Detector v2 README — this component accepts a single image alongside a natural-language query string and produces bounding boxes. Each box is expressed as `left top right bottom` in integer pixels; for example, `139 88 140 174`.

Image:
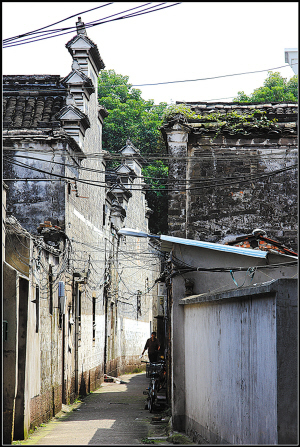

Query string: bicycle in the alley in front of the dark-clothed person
142 360 166 413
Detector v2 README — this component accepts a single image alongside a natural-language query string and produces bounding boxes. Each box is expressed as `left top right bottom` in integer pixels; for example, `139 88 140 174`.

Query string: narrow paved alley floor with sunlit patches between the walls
14 373 195 445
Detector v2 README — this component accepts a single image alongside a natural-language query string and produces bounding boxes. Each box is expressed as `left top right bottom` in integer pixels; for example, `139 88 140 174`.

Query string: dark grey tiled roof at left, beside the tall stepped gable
3 75 67 129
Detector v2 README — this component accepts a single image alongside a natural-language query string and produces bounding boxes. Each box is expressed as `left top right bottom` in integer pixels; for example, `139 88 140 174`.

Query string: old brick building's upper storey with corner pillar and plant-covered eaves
162 103 298 251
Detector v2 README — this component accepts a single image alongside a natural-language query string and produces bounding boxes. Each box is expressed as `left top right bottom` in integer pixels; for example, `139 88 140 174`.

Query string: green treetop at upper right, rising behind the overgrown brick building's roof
234 71 298 103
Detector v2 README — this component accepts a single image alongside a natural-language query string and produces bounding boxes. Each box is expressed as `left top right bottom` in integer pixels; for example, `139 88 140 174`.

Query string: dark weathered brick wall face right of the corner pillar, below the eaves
187 137 297 249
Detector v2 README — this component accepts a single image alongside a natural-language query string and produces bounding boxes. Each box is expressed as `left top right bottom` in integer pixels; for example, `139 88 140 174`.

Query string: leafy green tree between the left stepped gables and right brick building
98 70 168 234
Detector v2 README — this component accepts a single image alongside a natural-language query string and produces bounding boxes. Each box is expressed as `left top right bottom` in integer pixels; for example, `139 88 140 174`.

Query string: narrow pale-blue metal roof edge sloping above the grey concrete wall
160 235 268 258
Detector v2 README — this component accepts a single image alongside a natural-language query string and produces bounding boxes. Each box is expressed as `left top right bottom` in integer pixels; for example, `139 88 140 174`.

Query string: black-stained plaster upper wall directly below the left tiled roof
3 142 65 234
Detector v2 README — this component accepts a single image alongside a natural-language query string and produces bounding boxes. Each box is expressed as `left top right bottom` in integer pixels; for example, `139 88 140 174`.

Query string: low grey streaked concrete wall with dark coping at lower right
178 279 298 445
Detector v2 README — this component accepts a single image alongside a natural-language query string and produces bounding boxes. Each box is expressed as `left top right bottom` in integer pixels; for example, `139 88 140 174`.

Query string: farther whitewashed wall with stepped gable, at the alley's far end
108 154 160 371
